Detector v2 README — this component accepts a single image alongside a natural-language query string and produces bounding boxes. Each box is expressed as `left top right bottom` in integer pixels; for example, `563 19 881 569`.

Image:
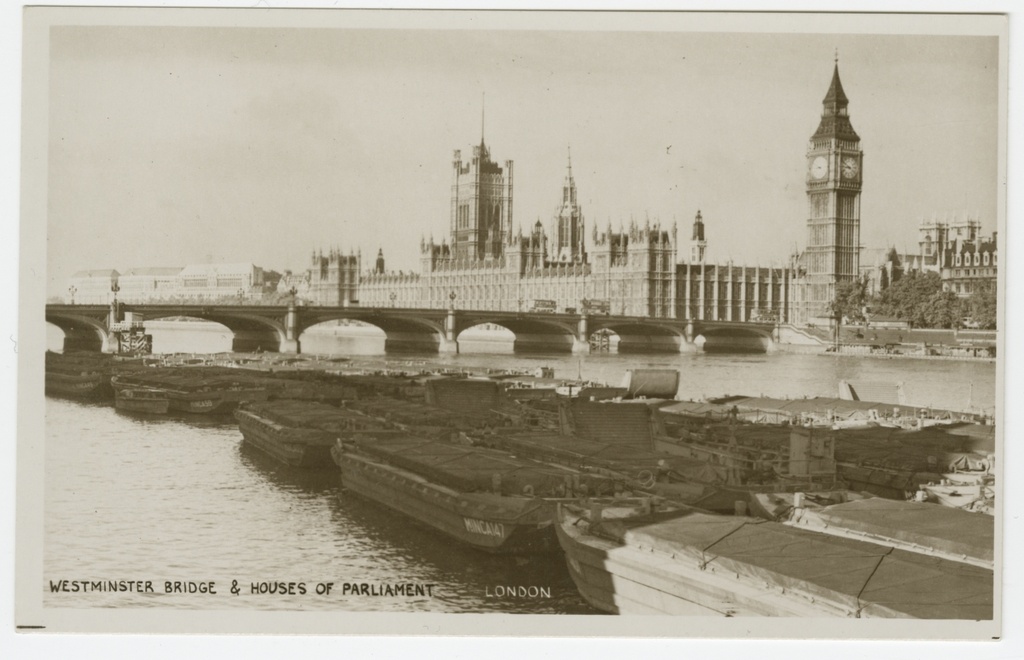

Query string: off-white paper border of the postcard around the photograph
6 2 1016 654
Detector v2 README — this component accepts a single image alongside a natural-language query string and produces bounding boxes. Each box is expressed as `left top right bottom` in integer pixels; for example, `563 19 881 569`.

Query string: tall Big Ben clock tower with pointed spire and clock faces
804 57 864 320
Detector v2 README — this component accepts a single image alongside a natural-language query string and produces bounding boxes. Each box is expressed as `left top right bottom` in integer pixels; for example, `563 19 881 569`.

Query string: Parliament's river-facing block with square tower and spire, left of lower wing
327 139 677 318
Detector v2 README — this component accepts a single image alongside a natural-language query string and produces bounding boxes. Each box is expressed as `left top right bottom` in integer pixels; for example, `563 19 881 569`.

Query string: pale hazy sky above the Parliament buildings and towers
48 27 998 295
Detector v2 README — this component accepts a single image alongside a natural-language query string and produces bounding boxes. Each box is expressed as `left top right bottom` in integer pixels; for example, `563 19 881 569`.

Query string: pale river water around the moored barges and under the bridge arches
42 327 995 614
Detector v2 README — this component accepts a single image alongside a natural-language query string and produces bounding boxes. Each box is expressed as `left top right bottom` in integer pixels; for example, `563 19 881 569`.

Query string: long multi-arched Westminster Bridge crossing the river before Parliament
46 303 777 354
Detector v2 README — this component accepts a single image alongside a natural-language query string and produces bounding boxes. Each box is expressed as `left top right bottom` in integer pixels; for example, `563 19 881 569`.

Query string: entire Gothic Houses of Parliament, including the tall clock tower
307 61 880 323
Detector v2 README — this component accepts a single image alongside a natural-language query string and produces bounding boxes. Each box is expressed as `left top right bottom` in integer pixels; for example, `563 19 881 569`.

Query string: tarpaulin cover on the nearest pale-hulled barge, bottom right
592 513 993 620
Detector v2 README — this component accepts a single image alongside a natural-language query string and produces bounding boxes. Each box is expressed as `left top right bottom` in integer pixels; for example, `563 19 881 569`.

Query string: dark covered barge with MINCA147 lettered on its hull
331 432 614 555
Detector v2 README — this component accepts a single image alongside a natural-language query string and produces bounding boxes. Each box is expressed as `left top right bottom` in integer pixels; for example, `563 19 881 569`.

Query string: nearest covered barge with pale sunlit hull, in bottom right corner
556 499 994 620
